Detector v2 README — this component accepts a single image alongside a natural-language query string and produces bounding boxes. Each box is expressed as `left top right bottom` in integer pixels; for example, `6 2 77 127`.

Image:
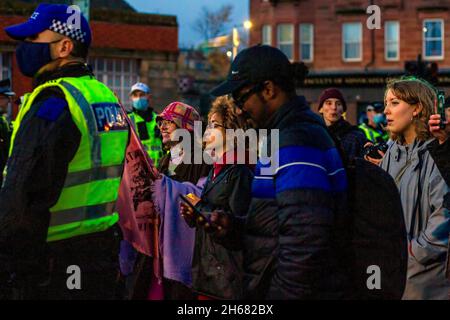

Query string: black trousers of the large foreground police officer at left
42 226 122 300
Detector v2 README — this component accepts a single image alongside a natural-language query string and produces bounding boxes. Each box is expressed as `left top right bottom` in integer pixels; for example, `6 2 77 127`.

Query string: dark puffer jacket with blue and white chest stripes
244 97 347 299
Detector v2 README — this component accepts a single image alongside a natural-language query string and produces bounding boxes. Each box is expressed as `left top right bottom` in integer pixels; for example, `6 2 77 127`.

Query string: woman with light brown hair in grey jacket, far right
381 78 450 300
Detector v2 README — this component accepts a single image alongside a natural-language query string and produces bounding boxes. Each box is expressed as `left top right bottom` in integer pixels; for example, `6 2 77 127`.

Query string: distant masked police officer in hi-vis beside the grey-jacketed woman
359 102 389 143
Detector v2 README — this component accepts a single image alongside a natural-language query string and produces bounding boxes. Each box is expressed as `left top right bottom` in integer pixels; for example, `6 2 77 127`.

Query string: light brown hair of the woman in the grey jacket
384 78 437 141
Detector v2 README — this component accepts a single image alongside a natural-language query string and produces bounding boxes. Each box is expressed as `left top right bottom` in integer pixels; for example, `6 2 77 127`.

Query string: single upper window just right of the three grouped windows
342 22 362 62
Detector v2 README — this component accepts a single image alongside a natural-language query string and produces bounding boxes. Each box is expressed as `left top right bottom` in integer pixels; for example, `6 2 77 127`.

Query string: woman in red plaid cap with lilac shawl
127 102 211 300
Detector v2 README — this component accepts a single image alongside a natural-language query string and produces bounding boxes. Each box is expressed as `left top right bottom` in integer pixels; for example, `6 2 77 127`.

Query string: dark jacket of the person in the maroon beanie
328 118 368 159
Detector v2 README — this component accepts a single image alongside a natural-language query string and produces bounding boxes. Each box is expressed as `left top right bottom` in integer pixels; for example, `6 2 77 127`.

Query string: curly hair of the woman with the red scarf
208 96 254 130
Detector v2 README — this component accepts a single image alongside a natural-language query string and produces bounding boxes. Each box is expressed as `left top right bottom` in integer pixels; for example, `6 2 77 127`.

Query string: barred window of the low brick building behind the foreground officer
89 58 139 108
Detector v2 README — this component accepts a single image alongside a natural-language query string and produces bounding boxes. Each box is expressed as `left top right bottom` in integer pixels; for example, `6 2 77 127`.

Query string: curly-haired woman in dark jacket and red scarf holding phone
181 97 253 300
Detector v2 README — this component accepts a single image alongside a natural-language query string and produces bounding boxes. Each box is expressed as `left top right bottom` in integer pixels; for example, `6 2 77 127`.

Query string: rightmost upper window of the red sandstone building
423 19 444 59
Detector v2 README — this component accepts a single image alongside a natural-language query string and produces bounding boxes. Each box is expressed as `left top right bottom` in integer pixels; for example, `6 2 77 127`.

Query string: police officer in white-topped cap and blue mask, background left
129 82 162 166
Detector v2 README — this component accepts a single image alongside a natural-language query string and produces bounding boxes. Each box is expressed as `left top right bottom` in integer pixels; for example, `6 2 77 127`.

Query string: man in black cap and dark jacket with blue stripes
205 45 347 299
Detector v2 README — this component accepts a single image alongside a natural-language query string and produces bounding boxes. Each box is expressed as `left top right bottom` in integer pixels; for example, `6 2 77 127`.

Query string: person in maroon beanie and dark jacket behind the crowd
319 88 367 160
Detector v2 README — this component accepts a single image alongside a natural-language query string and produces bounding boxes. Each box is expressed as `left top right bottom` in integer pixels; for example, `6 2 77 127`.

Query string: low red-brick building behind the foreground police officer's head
0 0 178 112
